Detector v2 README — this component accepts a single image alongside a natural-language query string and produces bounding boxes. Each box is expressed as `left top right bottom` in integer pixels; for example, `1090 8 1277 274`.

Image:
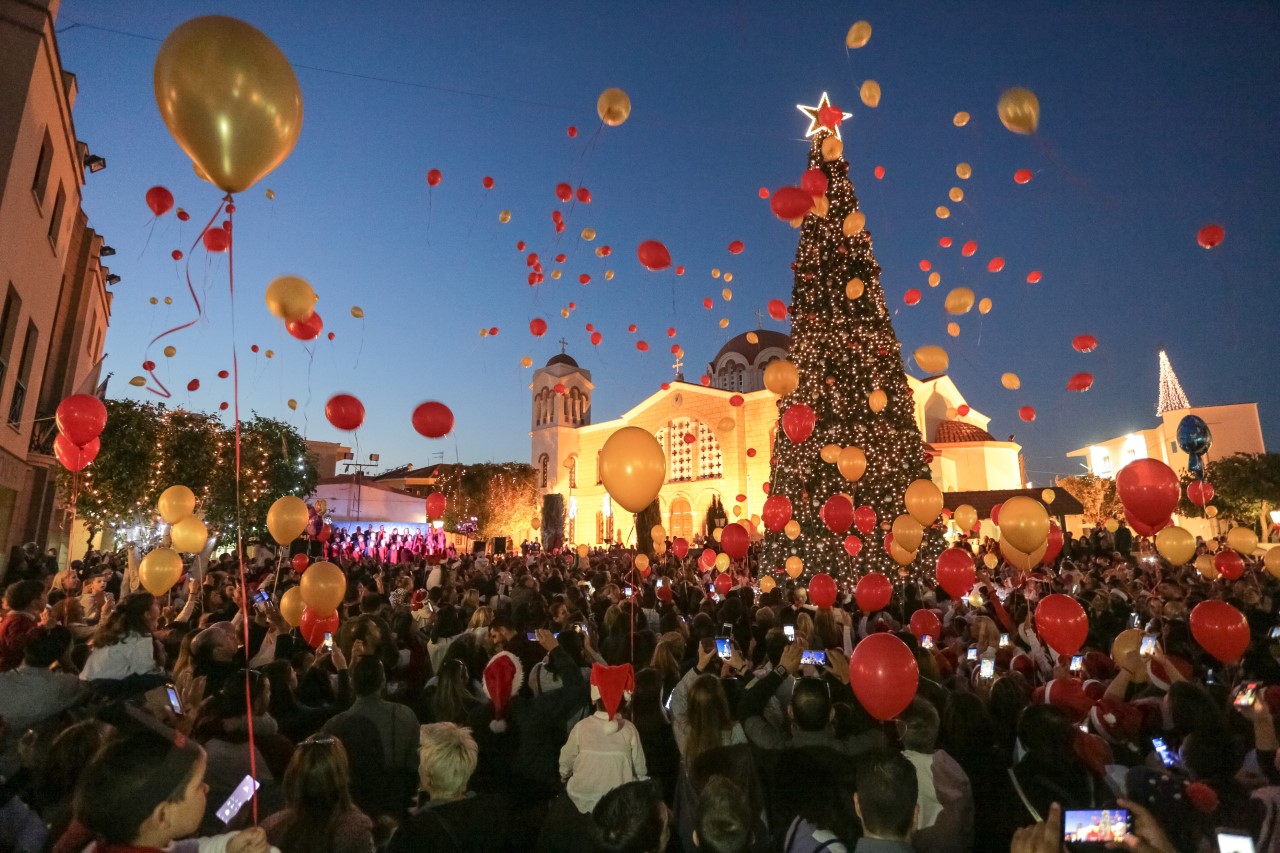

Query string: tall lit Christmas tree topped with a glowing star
762 93 943 585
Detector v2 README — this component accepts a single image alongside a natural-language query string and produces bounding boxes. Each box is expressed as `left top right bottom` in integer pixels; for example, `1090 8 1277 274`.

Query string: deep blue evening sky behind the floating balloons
58 0 1280 483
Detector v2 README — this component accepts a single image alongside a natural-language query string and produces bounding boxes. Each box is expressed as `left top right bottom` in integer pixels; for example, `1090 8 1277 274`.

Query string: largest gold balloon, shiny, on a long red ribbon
154 15 302 192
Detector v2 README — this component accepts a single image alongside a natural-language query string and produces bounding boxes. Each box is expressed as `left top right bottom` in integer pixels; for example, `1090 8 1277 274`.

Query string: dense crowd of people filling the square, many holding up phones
0 517 1280 853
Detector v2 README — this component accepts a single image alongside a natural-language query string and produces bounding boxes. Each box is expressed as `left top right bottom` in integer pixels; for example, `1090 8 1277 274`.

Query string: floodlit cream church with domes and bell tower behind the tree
530 329 1025 544
